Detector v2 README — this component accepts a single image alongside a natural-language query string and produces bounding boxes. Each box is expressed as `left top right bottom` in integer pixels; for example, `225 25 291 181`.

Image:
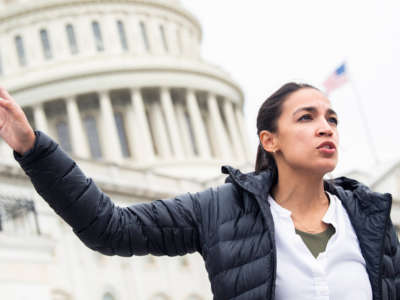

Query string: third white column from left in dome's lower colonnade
99 91 122 162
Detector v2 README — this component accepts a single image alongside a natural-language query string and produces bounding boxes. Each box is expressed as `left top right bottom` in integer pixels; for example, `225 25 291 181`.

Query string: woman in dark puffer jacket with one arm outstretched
0 83 400 300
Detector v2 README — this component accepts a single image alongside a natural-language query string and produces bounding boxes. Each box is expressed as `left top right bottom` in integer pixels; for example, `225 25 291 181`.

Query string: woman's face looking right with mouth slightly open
275 88 339 175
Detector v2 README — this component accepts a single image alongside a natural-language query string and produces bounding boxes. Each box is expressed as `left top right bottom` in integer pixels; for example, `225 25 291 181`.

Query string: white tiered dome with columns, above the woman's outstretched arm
0 0 252 179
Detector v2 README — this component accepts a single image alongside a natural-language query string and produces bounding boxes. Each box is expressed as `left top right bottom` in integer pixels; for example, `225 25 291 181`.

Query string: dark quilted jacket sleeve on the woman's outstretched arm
14 132 207 256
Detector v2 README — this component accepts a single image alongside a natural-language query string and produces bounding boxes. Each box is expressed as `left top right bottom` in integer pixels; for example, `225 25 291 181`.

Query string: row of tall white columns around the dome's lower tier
11 85 252 164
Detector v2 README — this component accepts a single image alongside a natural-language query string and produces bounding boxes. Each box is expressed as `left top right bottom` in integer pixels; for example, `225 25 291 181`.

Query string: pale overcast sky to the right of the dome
181 0 400 173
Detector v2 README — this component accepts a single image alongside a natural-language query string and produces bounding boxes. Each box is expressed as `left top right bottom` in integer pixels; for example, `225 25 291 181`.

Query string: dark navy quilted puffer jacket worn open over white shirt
15 132 400 300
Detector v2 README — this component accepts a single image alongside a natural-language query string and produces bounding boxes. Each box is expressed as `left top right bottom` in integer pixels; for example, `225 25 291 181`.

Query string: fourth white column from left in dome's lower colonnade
131 89 154 161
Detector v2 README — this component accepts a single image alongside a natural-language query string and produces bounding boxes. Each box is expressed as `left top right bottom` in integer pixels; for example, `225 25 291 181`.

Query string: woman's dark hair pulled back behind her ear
255 82 318 179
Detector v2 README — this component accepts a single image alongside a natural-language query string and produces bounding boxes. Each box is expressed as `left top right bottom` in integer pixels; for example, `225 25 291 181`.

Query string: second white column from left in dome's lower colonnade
65 96 90 158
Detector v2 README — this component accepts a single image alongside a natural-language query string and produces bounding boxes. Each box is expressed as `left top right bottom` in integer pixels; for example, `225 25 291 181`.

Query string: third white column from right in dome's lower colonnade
207 93 232 159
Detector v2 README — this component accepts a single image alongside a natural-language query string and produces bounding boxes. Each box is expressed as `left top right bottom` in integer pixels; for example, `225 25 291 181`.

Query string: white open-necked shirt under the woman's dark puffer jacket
268 194 372 300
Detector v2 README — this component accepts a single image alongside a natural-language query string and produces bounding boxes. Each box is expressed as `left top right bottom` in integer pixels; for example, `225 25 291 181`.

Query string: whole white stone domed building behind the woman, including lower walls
0 0 254 300
